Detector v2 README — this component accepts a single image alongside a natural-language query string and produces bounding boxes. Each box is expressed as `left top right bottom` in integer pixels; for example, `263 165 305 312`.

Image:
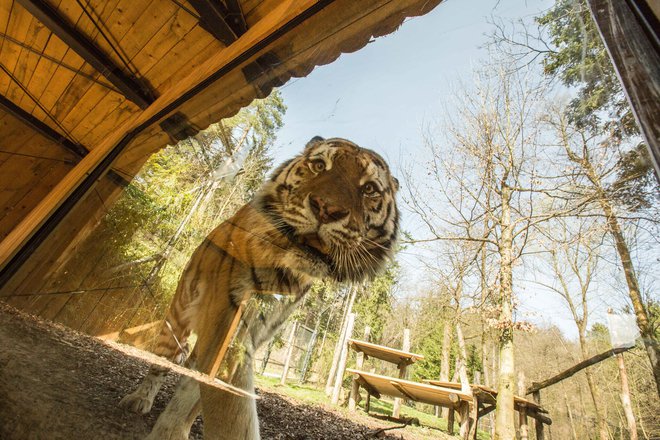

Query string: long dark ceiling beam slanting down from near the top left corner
17 0 155 109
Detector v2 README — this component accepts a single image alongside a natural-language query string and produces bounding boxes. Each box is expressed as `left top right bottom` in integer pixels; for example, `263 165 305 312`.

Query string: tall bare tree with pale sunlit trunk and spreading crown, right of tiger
406 69 560 439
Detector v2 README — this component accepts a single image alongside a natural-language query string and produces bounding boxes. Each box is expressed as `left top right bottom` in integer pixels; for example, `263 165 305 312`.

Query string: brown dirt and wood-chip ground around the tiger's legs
0 302 408 440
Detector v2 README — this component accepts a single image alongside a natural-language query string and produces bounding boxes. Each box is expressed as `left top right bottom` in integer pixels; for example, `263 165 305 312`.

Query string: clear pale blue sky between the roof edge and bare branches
266 0 628 336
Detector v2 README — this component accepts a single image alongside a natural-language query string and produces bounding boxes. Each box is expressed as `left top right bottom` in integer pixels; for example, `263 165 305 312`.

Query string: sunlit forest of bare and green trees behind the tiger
42 0 660 440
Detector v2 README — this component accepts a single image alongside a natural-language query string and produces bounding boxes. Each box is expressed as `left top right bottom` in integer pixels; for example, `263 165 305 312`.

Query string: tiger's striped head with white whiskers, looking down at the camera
261 137 399 281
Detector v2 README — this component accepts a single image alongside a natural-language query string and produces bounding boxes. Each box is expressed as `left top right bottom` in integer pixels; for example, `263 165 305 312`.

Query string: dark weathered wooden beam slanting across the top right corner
587 0 660 180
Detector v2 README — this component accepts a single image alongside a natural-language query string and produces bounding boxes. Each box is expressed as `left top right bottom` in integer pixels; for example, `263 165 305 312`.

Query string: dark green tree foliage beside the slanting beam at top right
536 0 638 138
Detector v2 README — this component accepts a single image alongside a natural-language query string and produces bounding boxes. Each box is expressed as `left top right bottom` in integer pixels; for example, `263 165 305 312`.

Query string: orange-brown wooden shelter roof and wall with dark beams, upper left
0 0 441 335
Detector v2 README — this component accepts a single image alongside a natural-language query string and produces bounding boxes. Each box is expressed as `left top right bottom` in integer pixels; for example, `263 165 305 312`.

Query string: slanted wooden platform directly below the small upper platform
346 368 473 407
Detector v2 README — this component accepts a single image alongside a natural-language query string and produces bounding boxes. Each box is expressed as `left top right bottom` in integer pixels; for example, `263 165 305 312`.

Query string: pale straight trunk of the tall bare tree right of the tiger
495 183 516 440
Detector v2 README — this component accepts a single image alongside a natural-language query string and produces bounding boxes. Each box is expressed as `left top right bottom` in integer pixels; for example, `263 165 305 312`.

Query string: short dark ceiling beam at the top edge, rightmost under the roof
188 0 247 46
